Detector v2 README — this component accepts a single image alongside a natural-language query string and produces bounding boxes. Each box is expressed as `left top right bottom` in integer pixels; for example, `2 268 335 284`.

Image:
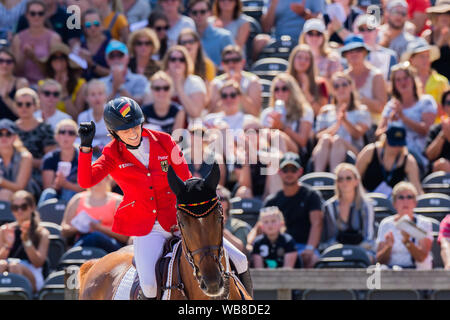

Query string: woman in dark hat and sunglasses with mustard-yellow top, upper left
43 43 86 119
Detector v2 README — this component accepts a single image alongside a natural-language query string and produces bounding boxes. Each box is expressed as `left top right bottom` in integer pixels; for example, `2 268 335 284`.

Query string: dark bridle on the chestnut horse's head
177 199 225 284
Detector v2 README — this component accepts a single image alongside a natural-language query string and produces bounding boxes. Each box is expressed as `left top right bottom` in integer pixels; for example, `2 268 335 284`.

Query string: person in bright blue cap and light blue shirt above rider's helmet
100 40 150 103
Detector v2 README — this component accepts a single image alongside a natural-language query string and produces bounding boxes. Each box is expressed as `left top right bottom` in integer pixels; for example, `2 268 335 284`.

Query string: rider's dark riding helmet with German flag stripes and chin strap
103 97 144 149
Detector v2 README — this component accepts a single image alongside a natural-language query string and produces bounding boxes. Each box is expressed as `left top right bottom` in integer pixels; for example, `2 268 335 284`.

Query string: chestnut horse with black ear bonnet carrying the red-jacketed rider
79 164 251 300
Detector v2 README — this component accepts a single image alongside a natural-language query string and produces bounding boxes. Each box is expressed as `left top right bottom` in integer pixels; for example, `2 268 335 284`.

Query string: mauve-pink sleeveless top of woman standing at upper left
18 29 54 84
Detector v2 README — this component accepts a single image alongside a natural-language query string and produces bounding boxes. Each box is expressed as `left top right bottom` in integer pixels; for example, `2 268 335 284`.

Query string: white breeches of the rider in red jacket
133 221 248 298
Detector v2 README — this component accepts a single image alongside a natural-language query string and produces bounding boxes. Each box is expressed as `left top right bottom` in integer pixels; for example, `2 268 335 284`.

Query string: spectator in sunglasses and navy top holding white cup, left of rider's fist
38 119 84 206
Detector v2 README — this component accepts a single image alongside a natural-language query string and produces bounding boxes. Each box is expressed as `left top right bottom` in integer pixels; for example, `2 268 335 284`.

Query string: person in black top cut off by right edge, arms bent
425 90 450 172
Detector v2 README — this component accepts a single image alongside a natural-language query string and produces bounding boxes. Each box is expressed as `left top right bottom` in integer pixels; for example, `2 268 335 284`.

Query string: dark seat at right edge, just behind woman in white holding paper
414 193 450 221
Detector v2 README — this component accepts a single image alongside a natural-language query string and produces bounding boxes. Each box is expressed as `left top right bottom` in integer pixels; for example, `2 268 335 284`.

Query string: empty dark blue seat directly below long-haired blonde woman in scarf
314 244 371 269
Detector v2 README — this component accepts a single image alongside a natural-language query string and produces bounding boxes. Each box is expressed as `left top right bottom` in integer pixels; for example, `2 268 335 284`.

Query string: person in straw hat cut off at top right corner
422 0 450 79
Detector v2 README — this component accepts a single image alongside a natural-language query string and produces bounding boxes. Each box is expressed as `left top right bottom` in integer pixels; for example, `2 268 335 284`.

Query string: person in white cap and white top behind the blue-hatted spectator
353 14 397 81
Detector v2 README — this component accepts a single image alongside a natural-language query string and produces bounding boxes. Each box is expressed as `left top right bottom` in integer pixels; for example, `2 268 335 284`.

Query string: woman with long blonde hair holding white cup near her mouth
261 73 314 156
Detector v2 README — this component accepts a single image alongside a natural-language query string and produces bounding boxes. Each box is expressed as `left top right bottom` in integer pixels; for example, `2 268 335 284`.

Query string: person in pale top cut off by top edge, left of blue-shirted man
158 0 195 47
